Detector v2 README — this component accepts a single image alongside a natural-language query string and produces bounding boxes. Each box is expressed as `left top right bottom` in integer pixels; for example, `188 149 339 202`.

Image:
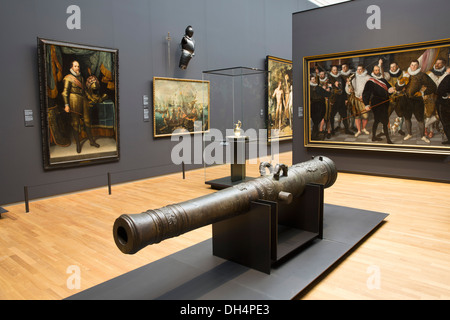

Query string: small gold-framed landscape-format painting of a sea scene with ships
153 77 210 137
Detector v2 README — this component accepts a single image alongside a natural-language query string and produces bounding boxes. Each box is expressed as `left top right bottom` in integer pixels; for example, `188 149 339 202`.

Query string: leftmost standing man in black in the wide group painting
309 76 331 140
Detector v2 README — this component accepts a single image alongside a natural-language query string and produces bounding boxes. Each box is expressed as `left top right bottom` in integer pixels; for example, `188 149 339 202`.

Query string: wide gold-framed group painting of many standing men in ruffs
303 39 450 154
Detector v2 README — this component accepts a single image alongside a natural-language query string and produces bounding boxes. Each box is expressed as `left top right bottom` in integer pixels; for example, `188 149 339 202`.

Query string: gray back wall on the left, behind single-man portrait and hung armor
0 0 315 205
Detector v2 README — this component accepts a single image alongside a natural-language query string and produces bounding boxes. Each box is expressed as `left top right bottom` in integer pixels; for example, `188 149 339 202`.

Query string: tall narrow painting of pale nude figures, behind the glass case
266 56 293 142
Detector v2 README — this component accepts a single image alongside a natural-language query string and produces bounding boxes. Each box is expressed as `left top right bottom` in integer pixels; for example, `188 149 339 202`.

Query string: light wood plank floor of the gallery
0 153 450 300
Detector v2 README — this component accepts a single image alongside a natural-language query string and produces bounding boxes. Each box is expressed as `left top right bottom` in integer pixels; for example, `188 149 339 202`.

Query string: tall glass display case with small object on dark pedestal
202 67 278 189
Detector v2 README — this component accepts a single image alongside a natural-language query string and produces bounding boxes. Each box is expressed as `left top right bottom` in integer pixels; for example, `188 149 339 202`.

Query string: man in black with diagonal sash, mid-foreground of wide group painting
362 66 395 144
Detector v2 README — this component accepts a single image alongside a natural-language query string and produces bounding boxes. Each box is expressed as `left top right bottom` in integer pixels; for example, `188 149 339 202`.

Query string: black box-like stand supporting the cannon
212 184 324 274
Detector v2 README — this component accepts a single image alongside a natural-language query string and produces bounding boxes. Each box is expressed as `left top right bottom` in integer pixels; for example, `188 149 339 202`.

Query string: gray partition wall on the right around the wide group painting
292 0 450 181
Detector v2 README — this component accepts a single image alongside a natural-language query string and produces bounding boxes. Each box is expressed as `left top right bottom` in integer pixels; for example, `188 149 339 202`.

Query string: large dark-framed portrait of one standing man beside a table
38 38 119 169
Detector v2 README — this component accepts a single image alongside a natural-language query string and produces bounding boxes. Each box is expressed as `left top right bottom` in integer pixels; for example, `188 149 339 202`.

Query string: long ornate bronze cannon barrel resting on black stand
113 156 337 254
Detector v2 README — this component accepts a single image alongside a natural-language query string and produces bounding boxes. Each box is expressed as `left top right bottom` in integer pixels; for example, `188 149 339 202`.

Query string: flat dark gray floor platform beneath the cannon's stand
67 204 388 300
